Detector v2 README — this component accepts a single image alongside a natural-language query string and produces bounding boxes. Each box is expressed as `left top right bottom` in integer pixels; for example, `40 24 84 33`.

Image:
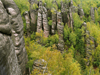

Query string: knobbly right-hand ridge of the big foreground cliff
2 0 28 75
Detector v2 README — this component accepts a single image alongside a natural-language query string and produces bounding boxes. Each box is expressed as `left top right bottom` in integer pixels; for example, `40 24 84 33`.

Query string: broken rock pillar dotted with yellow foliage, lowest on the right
83 22 95 66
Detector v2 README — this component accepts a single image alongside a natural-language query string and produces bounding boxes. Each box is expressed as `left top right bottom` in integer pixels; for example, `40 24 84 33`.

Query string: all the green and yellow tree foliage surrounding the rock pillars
14 0 100 75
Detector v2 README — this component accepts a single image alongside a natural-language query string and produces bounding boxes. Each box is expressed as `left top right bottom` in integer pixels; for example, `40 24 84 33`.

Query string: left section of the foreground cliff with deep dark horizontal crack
0 0 22 75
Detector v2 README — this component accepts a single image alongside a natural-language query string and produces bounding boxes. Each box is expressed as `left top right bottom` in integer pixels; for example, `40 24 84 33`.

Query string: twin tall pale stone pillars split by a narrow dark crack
37 1 49 37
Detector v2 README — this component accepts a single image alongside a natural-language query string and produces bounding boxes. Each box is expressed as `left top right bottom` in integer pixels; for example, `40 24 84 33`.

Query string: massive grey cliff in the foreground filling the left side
0 0 28 75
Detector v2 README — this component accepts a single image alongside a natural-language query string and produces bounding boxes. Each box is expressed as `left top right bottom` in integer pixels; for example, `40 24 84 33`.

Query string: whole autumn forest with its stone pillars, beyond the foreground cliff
14 0 100 75
